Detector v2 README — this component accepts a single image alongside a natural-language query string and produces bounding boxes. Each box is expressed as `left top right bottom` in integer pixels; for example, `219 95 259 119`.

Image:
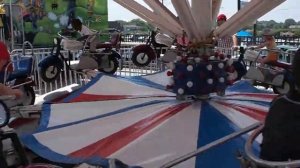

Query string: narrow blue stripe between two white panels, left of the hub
35 100 173 133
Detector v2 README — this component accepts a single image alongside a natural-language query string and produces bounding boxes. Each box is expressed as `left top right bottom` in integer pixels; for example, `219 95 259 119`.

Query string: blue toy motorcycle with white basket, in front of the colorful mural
38 30 121 82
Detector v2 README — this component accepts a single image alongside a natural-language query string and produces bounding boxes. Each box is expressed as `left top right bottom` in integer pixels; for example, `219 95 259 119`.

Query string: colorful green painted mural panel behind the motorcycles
2 0 108 46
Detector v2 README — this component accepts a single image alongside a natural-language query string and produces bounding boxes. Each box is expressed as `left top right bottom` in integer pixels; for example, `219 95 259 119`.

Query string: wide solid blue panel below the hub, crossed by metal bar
196 102 257 168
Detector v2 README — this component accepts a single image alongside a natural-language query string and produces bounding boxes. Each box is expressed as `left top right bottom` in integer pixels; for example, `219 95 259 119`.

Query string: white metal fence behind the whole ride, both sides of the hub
11 35 299 94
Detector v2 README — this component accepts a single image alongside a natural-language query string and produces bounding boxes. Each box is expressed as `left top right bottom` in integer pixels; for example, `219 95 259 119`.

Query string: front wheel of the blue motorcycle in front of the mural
39 65 61 83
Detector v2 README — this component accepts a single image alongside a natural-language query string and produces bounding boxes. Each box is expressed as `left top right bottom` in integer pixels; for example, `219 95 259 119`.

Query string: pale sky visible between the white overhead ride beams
108 0 300 22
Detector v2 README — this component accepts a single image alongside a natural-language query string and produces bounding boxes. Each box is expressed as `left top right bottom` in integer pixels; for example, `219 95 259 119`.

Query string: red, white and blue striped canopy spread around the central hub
22 73 276 168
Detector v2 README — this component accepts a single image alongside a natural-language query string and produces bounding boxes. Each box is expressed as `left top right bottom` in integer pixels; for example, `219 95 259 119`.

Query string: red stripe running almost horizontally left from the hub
70 94 170 103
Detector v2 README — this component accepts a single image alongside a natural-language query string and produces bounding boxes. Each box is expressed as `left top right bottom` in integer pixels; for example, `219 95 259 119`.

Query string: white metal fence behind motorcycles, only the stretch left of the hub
11 43 162 95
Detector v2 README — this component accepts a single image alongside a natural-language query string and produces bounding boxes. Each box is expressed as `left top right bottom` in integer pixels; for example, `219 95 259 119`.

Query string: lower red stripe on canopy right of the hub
217 101 267 121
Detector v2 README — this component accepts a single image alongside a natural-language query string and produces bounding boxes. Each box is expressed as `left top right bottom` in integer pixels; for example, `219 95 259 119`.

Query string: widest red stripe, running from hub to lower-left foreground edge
70 103 190 158
